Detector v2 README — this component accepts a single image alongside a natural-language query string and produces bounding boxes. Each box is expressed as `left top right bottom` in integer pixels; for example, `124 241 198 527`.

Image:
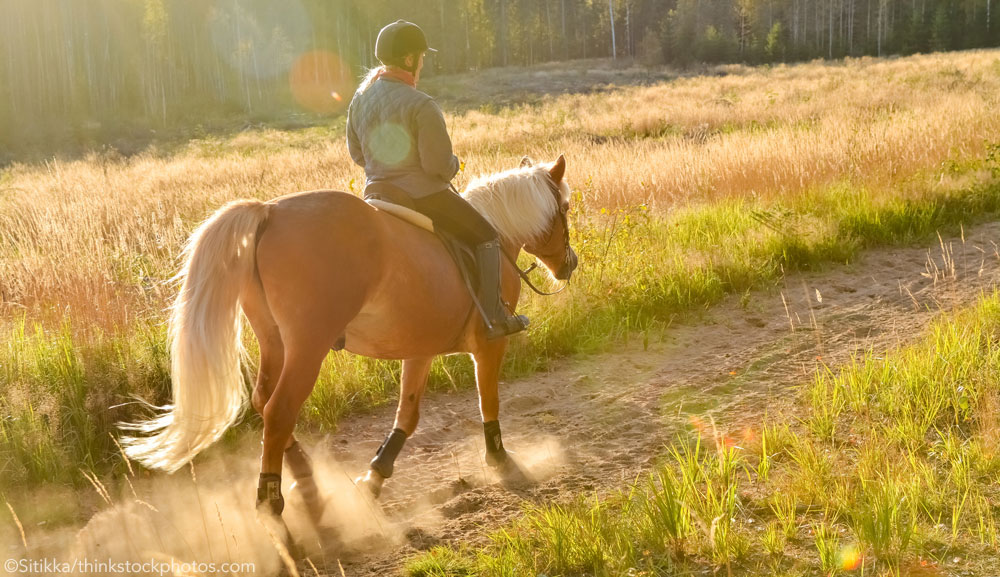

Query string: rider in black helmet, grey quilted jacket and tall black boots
347 20 528 340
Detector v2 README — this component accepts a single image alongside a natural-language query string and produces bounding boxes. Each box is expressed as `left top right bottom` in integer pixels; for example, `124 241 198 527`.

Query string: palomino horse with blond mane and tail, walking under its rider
125 156 577 515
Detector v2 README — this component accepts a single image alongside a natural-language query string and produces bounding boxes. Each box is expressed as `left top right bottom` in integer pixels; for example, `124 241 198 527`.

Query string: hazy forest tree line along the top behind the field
0 0 1000 151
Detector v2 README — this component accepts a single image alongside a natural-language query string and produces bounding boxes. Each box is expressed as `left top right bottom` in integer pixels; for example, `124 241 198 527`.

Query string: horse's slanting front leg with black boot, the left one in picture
358 357 434 497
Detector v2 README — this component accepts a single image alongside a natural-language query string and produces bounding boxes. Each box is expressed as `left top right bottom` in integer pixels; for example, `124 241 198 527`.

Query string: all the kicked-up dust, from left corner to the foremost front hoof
0 437 565 575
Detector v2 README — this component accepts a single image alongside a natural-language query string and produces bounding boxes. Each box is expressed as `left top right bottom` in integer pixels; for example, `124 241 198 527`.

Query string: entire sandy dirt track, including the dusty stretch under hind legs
8 222 1000 577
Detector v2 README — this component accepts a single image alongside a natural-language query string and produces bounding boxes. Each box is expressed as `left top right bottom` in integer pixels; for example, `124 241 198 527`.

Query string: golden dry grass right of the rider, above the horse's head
452 52 1000 207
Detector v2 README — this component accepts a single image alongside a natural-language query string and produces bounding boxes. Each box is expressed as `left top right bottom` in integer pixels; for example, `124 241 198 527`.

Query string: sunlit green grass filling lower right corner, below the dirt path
408 292 1000 576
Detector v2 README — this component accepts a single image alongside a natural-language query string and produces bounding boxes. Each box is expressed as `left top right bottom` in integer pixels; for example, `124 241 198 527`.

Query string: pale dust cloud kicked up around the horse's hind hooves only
0 442 403 575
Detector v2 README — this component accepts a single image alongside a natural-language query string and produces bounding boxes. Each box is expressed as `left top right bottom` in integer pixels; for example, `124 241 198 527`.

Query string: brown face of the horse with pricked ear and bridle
521 154 578 280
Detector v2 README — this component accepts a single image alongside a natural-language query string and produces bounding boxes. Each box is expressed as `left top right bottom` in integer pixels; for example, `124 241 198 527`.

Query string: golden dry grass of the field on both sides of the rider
0 52 1000 331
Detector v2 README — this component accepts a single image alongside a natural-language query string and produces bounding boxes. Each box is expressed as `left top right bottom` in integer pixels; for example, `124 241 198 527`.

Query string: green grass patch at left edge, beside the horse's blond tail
0 319 170 487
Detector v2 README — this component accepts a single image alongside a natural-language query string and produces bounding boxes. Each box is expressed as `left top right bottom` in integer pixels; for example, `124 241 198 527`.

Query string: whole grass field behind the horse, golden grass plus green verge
0 51 1000 492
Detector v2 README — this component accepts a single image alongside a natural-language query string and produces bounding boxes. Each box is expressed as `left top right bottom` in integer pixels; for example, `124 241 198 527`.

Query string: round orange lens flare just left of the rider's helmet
288 50 354 114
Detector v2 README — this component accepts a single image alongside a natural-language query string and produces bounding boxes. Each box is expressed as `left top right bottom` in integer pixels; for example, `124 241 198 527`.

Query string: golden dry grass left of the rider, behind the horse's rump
0 149 349 331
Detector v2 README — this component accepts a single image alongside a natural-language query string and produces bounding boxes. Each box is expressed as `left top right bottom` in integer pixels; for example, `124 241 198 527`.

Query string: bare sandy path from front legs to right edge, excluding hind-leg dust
318 222 1000 576
